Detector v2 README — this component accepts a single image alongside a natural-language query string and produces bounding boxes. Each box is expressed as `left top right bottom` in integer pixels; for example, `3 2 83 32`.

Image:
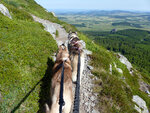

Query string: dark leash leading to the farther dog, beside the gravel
73 51 80 113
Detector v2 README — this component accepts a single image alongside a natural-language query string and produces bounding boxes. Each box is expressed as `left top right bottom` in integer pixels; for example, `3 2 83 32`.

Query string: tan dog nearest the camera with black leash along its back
46 45 73 113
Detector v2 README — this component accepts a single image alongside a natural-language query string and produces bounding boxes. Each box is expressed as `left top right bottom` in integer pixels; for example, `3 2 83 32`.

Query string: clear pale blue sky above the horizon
35 0 150 11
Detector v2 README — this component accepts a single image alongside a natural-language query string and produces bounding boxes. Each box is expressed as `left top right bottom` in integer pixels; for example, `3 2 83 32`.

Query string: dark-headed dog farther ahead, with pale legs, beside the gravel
68 31 85 83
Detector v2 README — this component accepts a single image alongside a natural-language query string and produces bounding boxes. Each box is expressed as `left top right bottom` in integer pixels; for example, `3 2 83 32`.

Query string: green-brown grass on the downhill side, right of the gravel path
79 34 150 113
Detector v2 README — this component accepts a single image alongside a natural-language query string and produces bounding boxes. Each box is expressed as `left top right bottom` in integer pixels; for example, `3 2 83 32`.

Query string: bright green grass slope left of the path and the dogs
0 6 57 113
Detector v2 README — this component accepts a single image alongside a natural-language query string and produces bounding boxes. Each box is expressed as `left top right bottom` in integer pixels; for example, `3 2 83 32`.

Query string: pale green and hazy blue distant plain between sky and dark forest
58 11 150 31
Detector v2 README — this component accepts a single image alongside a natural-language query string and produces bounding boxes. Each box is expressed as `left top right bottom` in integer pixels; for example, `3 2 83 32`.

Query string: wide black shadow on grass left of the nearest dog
38 58 54 113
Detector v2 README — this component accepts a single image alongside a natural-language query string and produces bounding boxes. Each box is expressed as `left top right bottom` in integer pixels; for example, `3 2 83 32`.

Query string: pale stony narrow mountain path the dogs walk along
32 15 99 113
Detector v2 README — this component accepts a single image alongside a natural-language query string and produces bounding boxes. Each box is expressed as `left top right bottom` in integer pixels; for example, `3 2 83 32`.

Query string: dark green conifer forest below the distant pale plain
85 29 150 74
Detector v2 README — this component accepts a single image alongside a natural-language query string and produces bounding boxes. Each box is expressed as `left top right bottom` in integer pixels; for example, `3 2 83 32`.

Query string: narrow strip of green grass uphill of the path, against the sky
1 0 77 32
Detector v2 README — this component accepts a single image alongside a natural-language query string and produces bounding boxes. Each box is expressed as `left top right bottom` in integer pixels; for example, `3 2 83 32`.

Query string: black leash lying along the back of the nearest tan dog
59 61 65 113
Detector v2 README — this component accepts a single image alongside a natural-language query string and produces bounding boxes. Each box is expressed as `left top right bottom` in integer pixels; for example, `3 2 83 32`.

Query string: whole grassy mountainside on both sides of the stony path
0 0 150 113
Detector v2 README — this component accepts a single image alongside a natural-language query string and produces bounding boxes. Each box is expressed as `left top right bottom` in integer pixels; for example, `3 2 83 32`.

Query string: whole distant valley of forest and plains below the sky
57 11 150 76
